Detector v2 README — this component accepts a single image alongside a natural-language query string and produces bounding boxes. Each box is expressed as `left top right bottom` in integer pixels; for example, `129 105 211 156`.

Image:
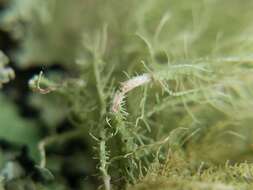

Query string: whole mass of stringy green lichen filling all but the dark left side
3 0 253 190
